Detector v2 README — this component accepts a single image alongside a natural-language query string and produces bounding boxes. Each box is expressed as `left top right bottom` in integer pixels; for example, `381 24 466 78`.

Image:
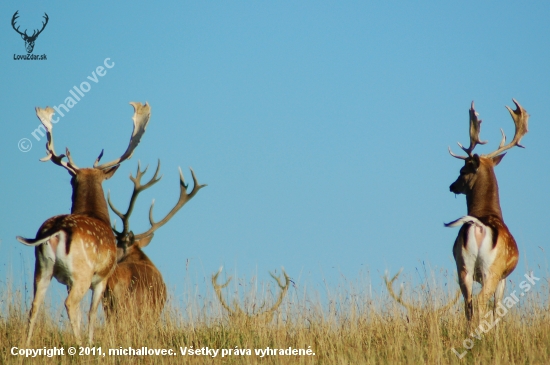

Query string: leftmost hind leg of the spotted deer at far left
26 252 53 347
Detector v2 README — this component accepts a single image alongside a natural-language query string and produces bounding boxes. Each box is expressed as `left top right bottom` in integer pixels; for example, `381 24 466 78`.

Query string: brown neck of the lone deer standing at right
466 166 502 219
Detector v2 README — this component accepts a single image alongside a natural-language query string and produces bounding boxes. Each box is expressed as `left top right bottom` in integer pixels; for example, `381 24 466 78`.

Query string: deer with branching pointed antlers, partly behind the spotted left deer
103 161 206 319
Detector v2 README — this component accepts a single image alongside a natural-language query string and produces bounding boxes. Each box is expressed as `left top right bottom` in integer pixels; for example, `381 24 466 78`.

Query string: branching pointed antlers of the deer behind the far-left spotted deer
107 160 206 240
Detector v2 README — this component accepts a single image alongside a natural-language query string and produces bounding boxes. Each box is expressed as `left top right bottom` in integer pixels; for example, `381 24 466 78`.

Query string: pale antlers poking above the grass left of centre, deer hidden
212 267 291 324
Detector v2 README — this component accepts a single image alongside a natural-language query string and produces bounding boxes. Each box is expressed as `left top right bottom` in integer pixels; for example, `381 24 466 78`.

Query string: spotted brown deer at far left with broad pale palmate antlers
17 102 151 346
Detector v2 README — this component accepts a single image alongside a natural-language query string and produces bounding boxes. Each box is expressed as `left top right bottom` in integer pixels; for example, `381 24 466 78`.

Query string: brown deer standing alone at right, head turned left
445 99 529 322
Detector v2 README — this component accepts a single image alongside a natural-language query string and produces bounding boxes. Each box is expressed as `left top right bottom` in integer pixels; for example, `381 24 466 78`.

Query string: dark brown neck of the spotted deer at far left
71 181 111 225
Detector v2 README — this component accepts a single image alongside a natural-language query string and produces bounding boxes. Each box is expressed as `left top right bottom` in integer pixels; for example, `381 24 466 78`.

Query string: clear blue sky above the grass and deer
0 1 550 304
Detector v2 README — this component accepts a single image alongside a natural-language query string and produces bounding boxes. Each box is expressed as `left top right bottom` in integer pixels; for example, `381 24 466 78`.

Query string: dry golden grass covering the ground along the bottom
0 268 550 364
